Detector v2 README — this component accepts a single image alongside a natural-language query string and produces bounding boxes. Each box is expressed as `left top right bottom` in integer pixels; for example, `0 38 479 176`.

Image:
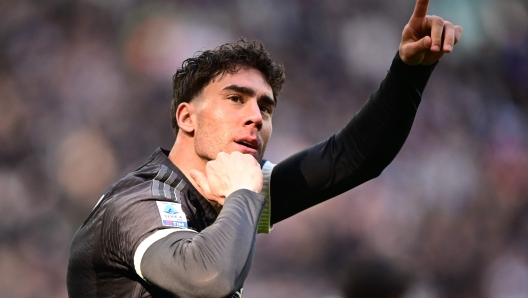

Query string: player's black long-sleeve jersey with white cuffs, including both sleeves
67 55 434 297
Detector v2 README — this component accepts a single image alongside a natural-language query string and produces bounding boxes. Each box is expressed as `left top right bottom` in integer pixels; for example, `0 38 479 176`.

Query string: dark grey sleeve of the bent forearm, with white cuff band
134 190 266 297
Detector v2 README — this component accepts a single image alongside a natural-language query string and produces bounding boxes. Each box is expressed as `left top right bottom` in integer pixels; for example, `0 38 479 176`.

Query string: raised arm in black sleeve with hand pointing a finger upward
270 0 462 224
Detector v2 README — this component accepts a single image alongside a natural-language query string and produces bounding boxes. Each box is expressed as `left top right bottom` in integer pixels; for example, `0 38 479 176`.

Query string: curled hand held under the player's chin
190 151 262 205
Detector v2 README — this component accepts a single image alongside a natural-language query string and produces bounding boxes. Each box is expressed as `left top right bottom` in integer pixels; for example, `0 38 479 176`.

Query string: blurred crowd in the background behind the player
0 0 528 298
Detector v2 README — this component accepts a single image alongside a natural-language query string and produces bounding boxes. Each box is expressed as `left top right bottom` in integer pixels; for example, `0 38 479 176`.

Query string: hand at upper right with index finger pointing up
399 0 462 65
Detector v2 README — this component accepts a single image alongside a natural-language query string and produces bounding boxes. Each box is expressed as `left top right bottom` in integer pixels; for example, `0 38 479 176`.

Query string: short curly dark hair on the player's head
171 38 285 135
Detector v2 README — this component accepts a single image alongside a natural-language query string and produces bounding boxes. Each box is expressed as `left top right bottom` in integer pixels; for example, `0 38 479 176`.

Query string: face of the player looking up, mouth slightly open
191 68 275 162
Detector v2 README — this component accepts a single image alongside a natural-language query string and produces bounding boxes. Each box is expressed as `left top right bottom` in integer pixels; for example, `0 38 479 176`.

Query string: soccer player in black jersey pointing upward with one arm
67 0 462 297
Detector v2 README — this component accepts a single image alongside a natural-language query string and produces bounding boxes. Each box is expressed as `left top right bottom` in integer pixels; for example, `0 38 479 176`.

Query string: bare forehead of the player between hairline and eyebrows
204 68 273 98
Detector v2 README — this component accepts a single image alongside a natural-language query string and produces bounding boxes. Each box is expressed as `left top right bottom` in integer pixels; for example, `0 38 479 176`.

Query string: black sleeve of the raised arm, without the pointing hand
270 54 436 224
